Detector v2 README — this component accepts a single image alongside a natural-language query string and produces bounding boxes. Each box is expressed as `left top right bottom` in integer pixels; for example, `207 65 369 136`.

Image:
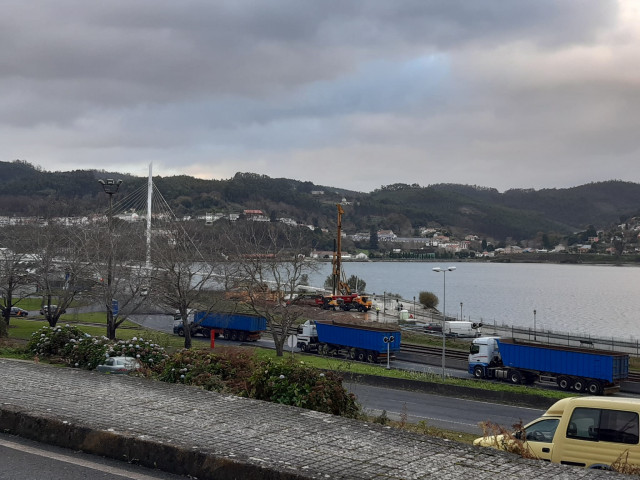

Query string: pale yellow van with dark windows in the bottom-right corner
473 397 640 469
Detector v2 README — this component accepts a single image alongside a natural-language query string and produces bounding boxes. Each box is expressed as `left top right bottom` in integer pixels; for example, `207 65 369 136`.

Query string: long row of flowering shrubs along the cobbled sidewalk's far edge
27 325 361 418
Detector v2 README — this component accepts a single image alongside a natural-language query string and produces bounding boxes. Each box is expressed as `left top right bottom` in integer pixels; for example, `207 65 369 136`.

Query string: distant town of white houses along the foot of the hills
6 199 640 261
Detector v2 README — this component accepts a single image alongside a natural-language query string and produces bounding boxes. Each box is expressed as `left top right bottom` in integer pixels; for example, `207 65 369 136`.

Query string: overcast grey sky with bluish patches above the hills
5 0 640 191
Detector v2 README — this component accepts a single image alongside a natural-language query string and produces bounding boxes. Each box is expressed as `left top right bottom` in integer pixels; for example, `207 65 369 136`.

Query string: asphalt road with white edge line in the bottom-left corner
0 433 185 480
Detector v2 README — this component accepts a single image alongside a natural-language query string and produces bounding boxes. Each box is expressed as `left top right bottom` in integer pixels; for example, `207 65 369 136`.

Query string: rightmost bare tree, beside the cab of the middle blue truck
225 221 316 356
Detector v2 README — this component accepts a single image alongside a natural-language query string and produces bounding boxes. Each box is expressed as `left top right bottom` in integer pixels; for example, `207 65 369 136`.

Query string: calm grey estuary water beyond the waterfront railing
310 262 640 340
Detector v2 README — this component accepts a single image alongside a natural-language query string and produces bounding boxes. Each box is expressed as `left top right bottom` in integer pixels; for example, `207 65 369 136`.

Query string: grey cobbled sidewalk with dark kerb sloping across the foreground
0 359 625 480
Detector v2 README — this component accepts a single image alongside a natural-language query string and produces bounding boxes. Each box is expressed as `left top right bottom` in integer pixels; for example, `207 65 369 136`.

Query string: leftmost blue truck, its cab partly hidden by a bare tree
173 311 267 342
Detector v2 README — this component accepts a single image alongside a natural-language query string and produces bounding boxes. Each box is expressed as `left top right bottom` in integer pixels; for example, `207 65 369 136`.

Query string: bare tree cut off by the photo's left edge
0 227 32 337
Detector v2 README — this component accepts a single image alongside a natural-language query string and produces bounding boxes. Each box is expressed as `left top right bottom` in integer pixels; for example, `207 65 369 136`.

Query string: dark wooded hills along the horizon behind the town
0 161 640 240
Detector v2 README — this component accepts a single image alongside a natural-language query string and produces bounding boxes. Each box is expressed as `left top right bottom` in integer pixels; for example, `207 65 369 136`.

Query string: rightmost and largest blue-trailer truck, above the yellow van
469 337 629 395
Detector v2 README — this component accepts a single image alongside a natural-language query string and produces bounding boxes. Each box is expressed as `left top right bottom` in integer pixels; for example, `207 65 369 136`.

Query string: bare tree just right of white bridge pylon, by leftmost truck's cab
149 222 220 348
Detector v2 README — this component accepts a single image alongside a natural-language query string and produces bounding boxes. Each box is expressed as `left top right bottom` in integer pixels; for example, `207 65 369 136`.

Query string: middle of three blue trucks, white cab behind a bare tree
297 320 401 363
